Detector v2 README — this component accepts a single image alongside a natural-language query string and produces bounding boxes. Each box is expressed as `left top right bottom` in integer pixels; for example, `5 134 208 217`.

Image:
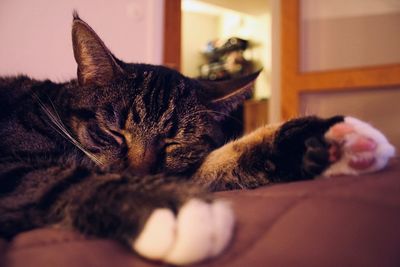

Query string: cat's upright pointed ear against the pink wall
72 12 123 85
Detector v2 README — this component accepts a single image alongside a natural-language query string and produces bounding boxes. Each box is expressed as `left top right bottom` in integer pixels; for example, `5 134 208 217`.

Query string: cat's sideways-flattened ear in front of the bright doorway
200 70 262 119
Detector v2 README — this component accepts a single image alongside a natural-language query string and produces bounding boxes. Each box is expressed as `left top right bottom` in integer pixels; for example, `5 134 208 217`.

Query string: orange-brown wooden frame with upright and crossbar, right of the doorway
281 0 400 120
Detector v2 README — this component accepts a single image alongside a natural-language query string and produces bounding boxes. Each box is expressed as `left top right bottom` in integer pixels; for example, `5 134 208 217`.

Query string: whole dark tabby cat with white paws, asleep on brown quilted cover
0 14 394 265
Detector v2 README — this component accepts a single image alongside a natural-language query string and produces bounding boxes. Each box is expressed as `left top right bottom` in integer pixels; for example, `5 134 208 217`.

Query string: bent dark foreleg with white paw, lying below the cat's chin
62 177 234 265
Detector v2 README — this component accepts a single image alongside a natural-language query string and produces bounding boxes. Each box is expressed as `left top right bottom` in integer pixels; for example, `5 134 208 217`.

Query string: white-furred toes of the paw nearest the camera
132 199 234 265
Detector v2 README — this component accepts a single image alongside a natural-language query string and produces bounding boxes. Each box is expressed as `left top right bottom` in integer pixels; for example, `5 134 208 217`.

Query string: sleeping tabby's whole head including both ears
69 14 258 174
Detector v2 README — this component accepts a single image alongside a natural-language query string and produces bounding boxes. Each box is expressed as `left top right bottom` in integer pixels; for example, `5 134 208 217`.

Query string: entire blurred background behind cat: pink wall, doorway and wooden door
0 0 400 149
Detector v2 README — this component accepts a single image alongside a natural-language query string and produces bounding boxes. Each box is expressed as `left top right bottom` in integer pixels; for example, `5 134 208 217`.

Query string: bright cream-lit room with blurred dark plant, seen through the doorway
181 0 272 138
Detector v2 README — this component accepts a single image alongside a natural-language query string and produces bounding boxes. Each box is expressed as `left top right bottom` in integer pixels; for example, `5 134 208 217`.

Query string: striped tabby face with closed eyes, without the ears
71 65 221 174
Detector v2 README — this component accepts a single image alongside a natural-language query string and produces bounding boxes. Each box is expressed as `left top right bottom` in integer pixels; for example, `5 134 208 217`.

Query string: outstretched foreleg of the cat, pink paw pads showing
193 116 395 190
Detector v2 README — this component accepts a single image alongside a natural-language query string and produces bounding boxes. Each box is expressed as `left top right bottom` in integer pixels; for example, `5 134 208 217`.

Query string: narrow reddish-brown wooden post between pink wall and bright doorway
163 0 182 70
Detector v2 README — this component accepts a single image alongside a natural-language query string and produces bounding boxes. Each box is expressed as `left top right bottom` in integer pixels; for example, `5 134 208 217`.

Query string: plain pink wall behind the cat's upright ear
0 0 164 81
